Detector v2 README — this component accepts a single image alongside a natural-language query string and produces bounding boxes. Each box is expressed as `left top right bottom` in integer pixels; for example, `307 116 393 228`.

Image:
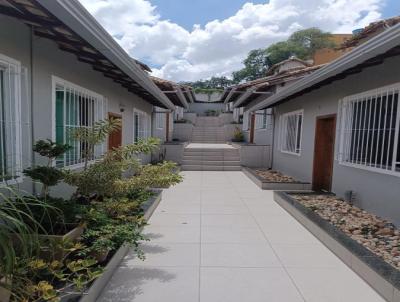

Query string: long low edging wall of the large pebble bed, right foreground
274 192 400 302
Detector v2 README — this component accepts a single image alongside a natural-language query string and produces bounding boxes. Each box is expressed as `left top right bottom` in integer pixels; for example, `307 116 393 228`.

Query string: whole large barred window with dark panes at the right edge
339 84 400 175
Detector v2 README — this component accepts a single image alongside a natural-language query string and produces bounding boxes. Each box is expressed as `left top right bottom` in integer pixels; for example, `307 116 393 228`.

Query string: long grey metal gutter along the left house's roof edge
36 0 175 110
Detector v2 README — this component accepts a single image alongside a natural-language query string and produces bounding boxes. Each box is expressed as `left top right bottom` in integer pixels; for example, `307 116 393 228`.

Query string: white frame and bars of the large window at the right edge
337 82 400 177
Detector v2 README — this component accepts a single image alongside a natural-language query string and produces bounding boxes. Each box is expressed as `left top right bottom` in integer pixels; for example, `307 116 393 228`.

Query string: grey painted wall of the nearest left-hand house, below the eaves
0 16 152 194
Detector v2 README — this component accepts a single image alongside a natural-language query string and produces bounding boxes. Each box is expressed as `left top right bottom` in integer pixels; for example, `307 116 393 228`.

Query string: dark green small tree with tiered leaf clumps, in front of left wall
24 140 71 197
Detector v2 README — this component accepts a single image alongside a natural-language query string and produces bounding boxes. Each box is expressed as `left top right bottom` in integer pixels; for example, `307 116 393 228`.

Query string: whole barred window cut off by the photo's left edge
0 55 22 182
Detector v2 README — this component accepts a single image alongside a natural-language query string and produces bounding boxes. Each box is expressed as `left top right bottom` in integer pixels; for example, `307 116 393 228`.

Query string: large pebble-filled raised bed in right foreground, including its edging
274 192 400 302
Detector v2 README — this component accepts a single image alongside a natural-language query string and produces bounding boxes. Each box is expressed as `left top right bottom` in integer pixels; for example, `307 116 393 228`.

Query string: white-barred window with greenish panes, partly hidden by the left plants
53 77 106 167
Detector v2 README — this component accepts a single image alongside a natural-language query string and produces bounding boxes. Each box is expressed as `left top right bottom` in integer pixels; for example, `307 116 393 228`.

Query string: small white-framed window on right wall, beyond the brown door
280 110 303 155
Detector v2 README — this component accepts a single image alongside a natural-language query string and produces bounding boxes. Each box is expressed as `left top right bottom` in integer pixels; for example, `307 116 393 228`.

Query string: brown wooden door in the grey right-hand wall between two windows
313 115 336 191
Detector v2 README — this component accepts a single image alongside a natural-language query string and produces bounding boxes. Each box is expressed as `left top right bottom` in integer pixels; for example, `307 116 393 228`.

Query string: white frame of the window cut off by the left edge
0 54 24 184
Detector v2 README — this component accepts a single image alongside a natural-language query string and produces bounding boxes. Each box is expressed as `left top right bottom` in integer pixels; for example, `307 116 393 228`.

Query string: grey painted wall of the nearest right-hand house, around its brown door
273 57 400 225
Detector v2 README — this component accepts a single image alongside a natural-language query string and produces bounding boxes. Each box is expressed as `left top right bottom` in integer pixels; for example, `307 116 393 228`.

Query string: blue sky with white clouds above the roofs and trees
80 0 400 82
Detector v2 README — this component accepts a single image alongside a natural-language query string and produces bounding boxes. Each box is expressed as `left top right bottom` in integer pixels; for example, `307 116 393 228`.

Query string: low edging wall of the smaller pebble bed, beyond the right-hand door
242 167 311 191
